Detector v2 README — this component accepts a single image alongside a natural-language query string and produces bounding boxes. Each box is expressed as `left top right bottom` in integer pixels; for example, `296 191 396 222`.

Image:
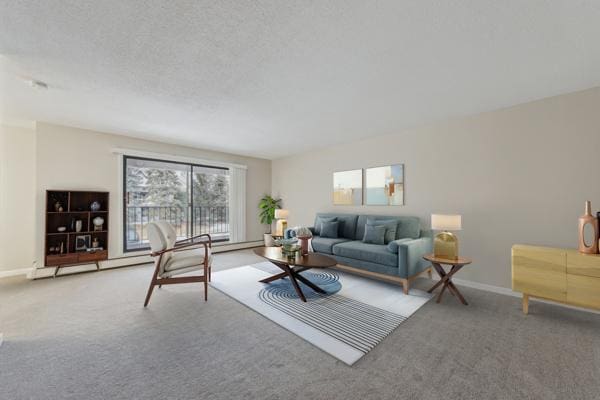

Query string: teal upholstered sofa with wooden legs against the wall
285 213 433 293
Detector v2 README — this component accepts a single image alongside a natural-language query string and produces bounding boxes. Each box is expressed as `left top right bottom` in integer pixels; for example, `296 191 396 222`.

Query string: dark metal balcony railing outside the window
125 206 229 251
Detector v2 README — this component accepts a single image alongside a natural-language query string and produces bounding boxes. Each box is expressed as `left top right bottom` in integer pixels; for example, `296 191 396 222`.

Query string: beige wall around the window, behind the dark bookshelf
29 123 271 268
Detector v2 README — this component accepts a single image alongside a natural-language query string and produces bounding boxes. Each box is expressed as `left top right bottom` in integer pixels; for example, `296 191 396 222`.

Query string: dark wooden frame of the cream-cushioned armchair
144 233 212 307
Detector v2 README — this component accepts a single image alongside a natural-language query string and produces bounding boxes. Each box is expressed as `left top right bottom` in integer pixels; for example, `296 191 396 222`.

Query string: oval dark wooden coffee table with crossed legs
254 247 337 302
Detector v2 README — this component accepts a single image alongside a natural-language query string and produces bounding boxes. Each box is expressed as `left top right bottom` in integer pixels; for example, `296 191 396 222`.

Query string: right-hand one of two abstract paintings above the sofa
364 164 404 206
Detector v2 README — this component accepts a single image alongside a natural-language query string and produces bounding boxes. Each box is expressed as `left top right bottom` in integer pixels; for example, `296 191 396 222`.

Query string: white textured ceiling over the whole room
0 0 600 158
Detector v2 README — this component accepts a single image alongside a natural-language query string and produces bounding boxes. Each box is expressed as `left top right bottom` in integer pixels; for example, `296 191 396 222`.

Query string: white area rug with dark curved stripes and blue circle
210 261 432 365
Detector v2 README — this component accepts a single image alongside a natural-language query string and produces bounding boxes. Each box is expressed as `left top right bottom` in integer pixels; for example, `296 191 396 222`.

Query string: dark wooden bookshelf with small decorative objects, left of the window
44 190 109 276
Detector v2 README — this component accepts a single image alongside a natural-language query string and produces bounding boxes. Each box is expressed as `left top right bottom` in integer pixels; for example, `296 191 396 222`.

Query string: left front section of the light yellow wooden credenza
512 246 567 301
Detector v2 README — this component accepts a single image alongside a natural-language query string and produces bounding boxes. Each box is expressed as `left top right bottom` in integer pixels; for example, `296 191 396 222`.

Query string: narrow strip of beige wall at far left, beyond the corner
0 125 36 271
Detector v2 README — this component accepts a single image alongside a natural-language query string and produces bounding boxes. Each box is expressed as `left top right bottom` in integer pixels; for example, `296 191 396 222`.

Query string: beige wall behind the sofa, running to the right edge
272 88 600 287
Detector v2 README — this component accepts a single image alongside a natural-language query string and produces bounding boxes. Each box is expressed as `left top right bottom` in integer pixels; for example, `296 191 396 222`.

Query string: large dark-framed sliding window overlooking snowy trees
123 155 230 252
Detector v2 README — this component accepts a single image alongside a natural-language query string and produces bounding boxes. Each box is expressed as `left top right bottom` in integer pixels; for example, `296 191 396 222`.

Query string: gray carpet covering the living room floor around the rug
0 251 600 400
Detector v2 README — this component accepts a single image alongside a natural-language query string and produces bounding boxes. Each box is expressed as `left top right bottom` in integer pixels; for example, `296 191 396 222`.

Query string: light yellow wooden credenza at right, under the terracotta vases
512 244 600 314
